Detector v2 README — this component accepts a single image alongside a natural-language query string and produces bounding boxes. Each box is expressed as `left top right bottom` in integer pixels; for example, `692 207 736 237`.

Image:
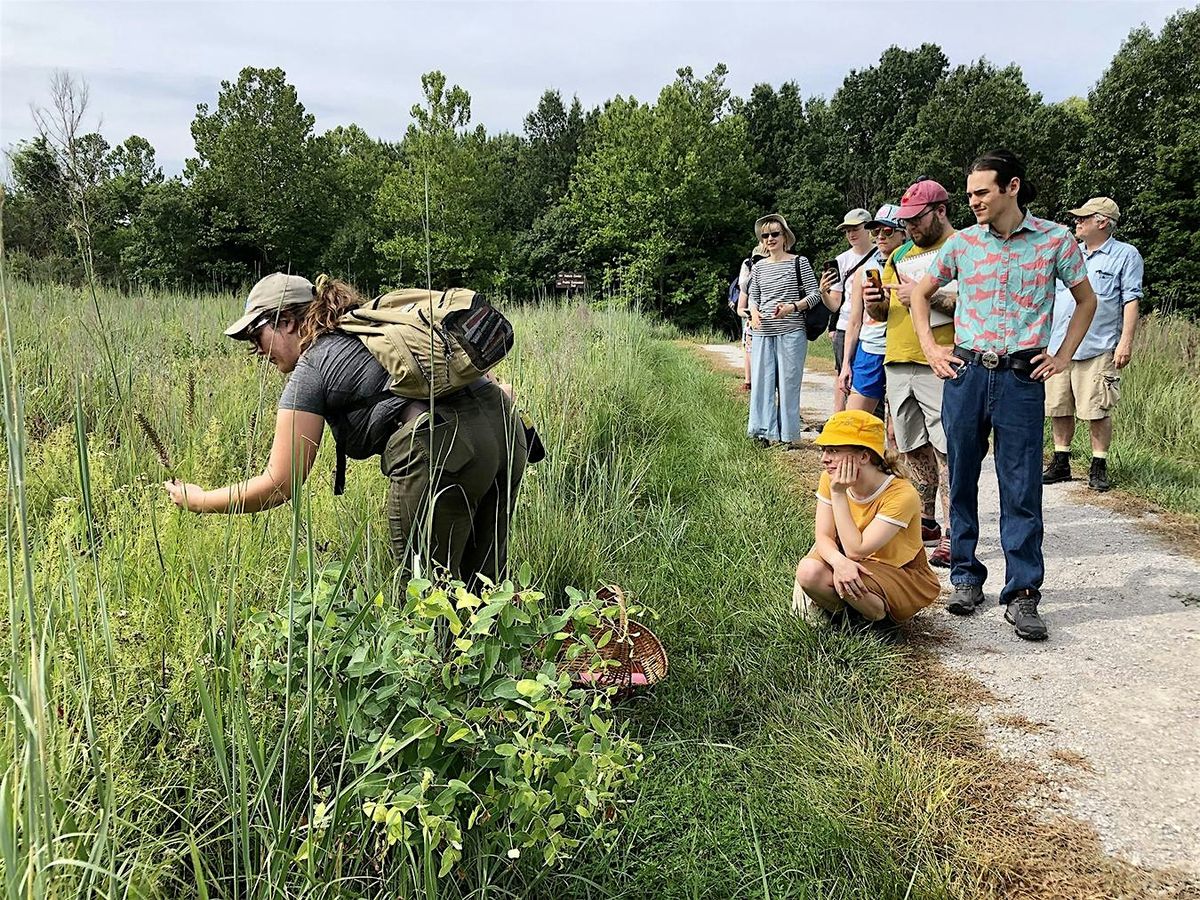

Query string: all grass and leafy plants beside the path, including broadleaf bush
0 283 1195 899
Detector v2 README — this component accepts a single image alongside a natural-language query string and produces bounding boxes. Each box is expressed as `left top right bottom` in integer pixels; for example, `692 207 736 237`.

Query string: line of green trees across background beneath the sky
2 7 1200 326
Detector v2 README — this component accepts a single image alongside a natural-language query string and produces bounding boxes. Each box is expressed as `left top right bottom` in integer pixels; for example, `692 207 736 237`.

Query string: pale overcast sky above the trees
0 0 1189 174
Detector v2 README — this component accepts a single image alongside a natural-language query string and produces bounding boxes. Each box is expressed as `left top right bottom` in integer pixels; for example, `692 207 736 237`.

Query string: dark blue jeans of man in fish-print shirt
942 362 1045 604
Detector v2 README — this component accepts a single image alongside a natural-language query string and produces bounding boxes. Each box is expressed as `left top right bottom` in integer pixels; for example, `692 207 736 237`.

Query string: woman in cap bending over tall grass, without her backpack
164 272 527 583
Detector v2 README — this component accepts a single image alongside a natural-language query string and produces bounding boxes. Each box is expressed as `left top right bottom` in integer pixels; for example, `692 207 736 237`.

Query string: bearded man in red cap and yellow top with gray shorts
864 178 958 569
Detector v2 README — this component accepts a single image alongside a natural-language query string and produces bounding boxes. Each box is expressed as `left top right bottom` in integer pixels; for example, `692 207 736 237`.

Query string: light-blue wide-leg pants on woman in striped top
746 329 809 440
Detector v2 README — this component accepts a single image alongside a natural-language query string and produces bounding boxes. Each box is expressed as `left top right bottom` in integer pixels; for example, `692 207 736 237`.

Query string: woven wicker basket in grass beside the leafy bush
558 584 668 697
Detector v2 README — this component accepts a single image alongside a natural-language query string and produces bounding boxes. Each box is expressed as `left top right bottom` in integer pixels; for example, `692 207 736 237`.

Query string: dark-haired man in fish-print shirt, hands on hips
911 150 1096 641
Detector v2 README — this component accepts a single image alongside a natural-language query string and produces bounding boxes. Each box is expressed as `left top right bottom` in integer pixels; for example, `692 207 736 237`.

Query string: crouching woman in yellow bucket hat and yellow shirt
793 409 941 622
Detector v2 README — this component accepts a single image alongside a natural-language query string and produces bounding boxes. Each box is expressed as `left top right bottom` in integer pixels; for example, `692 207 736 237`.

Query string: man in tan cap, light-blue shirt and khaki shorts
1042 197 1142 491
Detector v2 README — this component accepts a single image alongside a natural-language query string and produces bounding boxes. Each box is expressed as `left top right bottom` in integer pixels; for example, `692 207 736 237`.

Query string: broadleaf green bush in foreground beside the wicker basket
246 563 646 881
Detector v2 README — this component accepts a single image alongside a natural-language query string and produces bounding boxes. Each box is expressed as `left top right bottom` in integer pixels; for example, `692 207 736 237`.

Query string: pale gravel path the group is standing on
706 344 1200 872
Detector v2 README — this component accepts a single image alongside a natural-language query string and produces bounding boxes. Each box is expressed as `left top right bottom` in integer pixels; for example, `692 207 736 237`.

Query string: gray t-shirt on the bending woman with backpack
280 331 412 460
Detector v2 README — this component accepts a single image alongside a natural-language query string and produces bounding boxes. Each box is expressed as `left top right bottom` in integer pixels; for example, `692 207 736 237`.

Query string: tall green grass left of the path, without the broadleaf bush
0 284 1027 899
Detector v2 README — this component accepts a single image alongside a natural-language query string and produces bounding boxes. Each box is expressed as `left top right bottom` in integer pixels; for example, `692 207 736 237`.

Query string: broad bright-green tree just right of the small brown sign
565 65 755 325
